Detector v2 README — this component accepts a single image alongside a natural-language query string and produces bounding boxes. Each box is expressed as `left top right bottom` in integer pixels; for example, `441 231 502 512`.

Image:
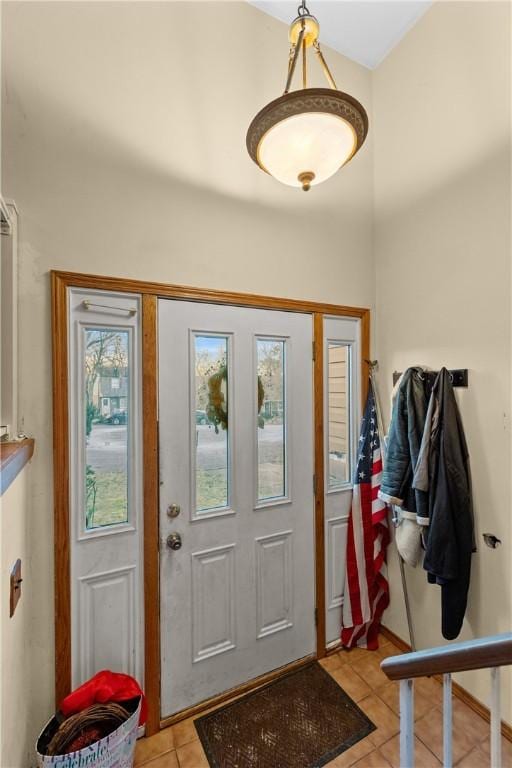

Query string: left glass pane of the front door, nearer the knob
194 335 229 513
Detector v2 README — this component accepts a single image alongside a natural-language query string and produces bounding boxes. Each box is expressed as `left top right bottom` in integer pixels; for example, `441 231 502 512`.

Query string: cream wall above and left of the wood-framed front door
3 2 374 756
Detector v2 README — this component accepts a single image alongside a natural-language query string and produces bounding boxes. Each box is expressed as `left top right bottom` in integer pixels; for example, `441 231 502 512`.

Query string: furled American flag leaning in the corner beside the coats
341 380 389 650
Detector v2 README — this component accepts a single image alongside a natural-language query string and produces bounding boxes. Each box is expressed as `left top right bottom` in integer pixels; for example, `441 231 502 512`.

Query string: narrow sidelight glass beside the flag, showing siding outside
327 341 350 490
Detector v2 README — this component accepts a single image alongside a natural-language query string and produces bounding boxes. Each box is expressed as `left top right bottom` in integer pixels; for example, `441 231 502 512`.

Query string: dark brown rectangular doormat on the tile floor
195 661 375 768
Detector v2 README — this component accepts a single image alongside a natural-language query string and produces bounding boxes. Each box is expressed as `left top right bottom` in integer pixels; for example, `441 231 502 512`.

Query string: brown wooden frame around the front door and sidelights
51 271 370 735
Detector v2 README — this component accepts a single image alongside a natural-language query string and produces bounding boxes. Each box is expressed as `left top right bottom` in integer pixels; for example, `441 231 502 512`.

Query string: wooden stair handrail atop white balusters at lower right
380 632 512 680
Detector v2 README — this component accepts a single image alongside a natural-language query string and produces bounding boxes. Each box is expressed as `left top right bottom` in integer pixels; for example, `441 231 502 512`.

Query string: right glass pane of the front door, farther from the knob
256 339 287 501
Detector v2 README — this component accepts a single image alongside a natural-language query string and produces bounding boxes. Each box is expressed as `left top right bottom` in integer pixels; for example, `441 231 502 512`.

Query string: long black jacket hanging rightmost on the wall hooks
413 368 476 640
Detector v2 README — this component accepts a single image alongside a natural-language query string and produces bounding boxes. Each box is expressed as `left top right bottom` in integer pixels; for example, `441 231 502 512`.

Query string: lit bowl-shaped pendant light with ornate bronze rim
247 0 368 191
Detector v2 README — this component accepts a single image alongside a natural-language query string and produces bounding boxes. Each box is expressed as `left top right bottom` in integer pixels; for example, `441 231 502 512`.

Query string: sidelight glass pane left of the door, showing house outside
84 328 130 530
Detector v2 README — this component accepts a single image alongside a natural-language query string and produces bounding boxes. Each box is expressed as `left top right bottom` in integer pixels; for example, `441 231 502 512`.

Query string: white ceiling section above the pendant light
249 0 432 69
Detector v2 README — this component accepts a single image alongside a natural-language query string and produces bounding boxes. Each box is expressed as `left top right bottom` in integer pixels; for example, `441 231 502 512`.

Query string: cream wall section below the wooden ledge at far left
0 465 36 768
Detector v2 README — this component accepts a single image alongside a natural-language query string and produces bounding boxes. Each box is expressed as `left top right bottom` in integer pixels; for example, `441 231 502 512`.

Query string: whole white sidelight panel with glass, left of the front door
68 288 144 688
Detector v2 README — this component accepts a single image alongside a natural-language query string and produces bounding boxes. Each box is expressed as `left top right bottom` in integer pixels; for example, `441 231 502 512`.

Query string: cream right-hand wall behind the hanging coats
373 2 512 722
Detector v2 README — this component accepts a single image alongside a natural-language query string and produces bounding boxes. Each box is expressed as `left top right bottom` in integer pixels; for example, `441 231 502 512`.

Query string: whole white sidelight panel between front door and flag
324 317 361 645
